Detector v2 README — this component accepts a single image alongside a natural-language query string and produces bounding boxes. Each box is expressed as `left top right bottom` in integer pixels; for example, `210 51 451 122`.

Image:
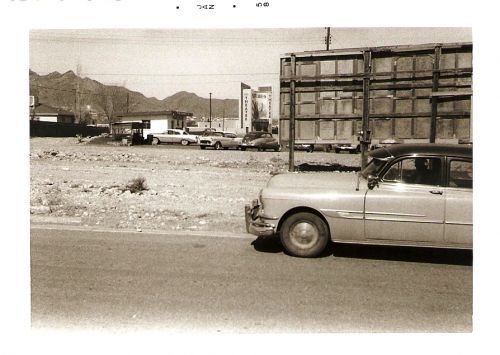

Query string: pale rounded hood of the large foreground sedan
266 172 358 191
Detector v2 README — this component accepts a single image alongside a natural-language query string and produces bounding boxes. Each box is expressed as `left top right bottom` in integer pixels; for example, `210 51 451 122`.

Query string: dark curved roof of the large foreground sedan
368 143 472 159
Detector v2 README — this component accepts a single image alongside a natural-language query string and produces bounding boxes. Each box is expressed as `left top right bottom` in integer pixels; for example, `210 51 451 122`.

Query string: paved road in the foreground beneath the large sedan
31 226 472 333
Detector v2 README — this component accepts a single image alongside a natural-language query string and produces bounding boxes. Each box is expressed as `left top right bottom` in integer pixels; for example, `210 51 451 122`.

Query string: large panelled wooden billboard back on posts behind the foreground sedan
279 42 472 171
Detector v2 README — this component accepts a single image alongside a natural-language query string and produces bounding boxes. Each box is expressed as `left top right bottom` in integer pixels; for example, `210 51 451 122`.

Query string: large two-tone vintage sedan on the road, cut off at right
245 144 472 257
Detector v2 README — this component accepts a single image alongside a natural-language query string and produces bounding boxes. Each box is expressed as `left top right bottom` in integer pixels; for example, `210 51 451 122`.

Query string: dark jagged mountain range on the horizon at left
29 70 239 123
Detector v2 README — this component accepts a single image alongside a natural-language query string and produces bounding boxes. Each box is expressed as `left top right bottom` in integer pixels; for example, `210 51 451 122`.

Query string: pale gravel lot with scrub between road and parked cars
30 138 360 233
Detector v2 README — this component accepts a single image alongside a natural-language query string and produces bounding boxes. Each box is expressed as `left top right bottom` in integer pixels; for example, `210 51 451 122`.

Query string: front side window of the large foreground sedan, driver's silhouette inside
382 157 441 185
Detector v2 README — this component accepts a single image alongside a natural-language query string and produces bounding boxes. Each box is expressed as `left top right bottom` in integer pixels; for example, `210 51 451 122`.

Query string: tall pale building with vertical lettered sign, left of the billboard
240 83 273 132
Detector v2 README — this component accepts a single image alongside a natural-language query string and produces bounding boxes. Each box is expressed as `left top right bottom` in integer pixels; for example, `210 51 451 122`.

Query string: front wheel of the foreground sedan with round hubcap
280 212 330 257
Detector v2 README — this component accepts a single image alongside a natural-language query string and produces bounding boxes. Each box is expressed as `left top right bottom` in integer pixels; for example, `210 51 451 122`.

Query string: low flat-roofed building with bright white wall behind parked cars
115 111 193 138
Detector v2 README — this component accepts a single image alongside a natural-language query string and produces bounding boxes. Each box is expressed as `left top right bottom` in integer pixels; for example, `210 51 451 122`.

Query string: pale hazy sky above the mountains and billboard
29 27 472 116
